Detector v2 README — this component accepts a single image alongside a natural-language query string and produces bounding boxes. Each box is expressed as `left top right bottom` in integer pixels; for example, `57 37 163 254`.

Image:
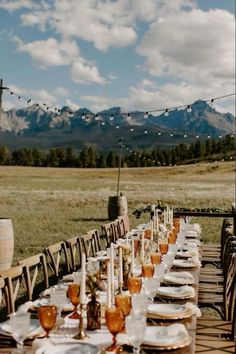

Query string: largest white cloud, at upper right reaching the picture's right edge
138 9 235 85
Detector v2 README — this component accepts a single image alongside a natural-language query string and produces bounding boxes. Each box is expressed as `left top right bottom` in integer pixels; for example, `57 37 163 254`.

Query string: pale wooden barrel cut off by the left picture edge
0 218 14 271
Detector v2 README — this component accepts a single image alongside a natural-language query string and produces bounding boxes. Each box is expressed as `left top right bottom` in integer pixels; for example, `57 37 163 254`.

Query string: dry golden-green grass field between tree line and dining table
0 162 235 262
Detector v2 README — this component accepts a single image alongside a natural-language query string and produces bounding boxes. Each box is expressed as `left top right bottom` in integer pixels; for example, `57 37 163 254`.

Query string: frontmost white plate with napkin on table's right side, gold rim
143 323 191 350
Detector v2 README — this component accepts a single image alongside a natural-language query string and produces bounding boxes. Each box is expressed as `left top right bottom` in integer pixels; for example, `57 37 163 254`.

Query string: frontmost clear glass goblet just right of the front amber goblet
125 315 146 354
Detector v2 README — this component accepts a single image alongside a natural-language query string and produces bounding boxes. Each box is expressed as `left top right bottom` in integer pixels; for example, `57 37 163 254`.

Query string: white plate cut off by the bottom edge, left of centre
35 343 100 354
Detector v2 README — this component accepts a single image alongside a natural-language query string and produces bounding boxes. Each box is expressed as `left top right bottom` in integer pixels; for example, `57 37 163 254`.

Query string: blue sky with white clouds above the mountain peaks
0 0 235 114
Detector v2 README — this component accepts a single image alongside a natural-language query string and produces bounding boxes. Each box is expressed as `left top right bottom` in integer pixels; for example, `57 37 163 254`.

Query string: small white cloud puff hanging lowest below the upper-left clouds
71 59 105 85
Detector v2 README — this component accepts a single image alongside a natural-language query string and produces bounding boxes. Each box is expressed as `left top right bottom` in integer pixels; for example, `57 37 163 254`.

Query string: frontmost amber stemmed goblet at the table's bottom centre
105 307 125 353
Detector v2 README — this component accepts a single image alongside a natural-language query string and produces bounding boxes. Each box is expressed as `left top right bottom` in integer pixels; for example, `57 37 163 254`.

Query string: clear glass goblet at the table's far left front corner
10 311 30 353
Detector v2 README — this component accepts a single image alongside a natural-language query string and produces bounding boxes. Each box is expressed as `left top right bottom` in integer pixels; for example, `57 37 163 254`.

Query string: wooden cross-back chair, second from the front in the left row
18 253 49 300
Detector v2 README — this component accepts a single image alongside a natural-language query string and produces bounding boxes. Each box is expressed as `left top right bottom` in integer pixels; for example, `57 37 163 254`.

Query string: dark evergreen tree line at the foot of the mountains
0 135 235 168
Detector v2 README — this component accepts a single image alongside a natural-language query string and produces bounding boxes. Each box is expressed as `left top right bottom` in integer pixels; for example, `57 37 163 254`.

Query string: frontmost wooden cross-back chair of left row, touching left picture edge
0 265 29 313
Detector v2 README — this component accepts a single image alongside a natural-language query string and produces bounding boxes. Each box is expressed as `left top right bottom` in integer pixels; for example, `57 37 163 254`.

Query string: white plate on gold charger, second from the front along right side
147 304 193 320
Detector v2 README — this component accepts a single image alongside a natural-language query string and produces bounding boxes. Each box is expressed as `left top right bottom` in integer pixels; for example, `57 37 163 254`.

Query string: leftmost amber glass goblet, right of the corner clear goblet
38 305 57 337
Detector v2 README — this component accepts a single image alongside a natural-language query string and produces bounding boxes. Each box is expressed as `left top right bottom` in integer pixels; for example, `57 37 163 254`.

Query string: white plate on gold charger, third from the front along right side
157 285 195 299
